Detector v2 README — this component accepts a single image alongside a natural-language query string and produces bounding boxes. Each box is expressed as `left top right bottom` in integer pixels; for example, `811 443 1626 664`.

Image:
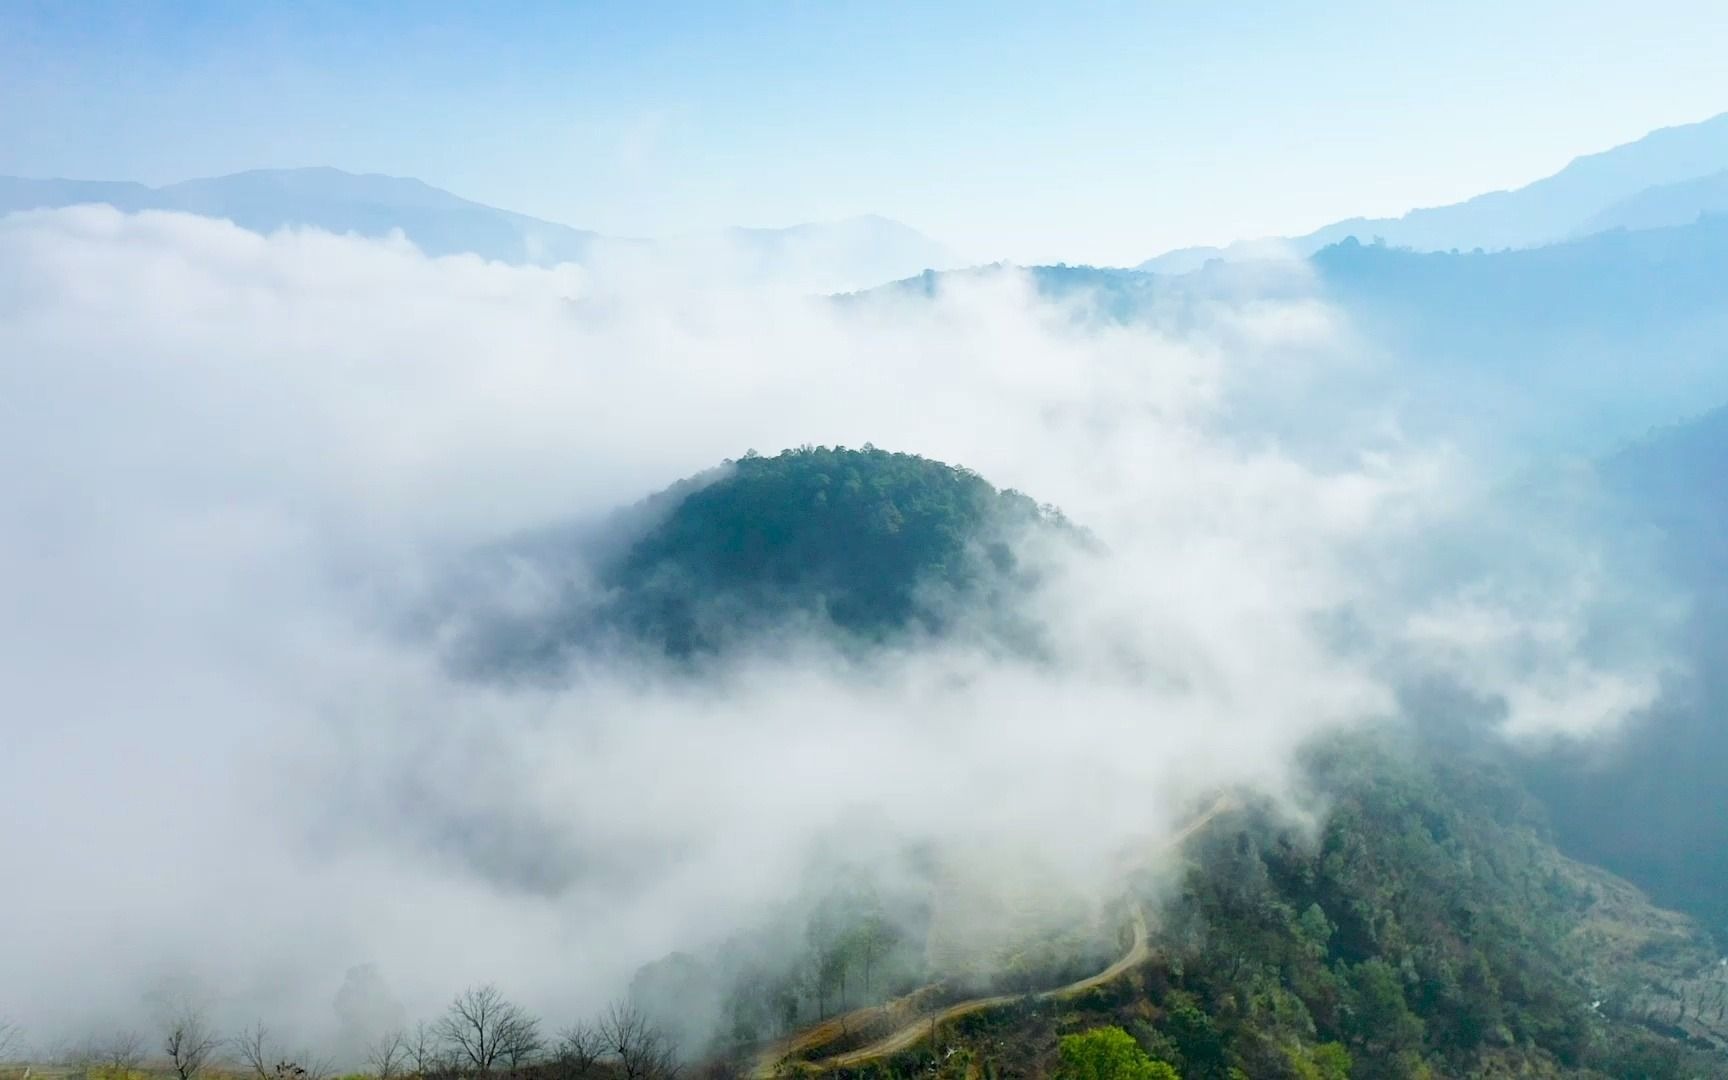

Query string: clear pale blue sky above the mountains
10 0 1728 263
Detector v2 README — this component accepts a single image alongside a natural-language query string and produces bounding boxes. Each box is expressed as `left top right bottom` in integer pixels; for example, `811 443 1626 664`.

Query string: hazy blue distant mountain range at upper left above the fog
0 168 962 292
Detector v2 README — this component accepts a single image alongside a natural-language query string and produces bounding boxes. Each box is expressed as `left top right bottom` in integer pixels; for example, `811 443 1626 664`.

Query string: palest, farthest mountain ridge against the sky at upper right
1137 112 1728 273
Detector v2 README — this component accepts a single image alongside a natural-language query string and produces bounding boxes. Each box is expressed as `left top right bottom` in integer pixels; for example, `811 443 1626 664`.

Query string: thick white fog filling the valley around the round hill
0 207 1673 1045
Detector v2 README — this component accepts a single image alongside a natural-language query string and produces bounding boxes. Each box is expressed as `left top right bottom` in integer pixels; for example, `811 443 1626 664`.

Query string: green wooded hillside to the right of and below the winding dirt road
798 736 1728 1080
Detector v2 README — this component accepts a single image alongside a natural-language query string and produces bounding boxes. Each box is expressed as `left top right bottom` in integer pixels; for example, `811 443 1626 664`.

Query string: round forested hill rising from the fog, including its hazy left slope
459 446 1089 669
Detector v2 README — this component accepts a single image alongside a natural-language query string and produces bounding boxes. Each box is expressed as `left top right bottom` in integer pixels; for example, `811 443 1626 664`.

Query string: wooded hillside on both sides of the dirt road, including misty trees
638 731 1728 1080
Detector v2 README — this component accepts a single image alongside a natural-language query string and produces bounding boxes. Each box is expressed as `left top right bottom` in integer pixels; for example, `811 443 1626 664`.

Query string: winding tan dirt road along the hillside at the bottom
748 797 1230 1080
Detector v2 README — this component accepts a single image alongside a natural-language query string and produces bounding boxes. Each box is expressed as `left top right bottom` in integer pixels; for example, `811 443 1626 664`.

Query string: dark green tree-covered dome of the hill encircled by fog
605 446 1061 653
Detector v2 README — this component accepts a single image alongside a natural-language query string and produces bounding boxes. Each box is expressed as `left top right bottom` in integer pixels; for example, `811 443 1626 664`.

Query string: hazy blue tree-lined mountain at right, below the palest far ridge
1299 218 1728 458
